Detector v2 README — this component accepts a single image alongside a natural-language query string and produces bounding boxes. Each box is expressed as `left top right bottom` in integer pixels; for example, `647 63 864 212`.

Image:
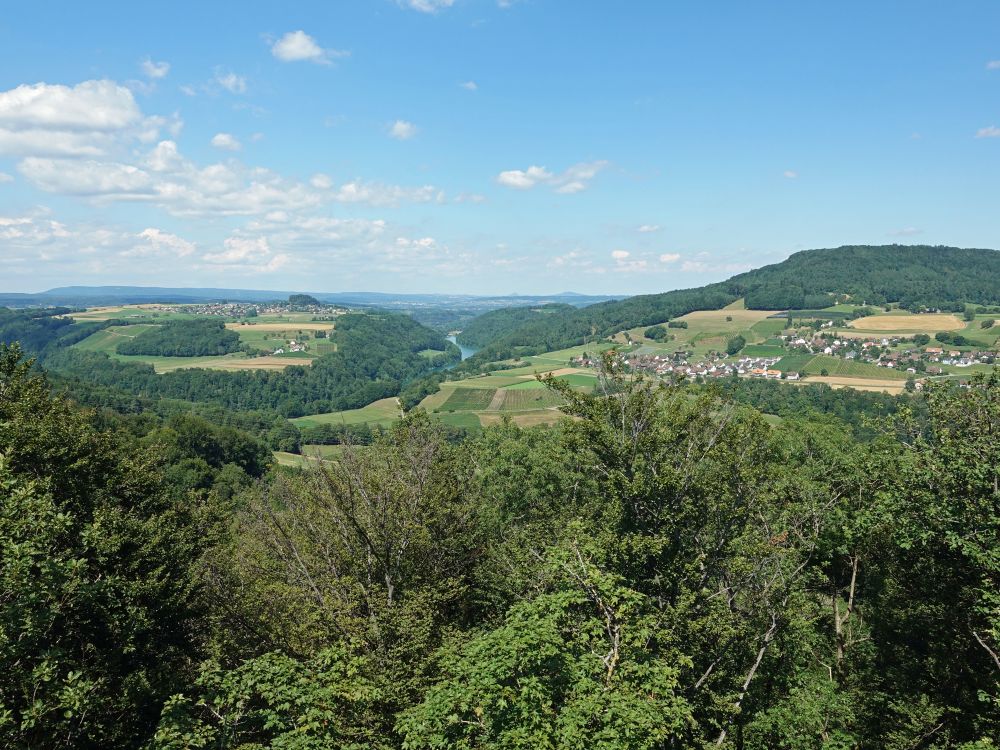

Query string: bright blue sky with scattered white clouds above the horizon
0 0 1000 294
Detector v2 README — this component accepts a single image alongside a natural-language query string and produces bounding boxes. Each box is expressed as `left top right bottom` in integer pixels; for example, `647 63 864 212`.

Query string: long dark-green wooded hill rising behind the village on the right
462 245 1000 370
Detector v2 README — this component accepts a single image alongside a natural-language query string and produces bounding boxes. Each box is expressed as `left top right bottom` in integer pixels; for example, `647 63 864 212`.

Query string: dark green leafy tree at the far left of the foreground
0 347 200 748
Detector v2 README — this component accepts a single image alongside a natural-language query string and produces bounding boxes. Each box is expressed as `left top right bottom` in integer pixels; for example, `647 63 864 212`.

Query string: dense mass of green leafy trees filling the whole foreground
0 347 1000 750
